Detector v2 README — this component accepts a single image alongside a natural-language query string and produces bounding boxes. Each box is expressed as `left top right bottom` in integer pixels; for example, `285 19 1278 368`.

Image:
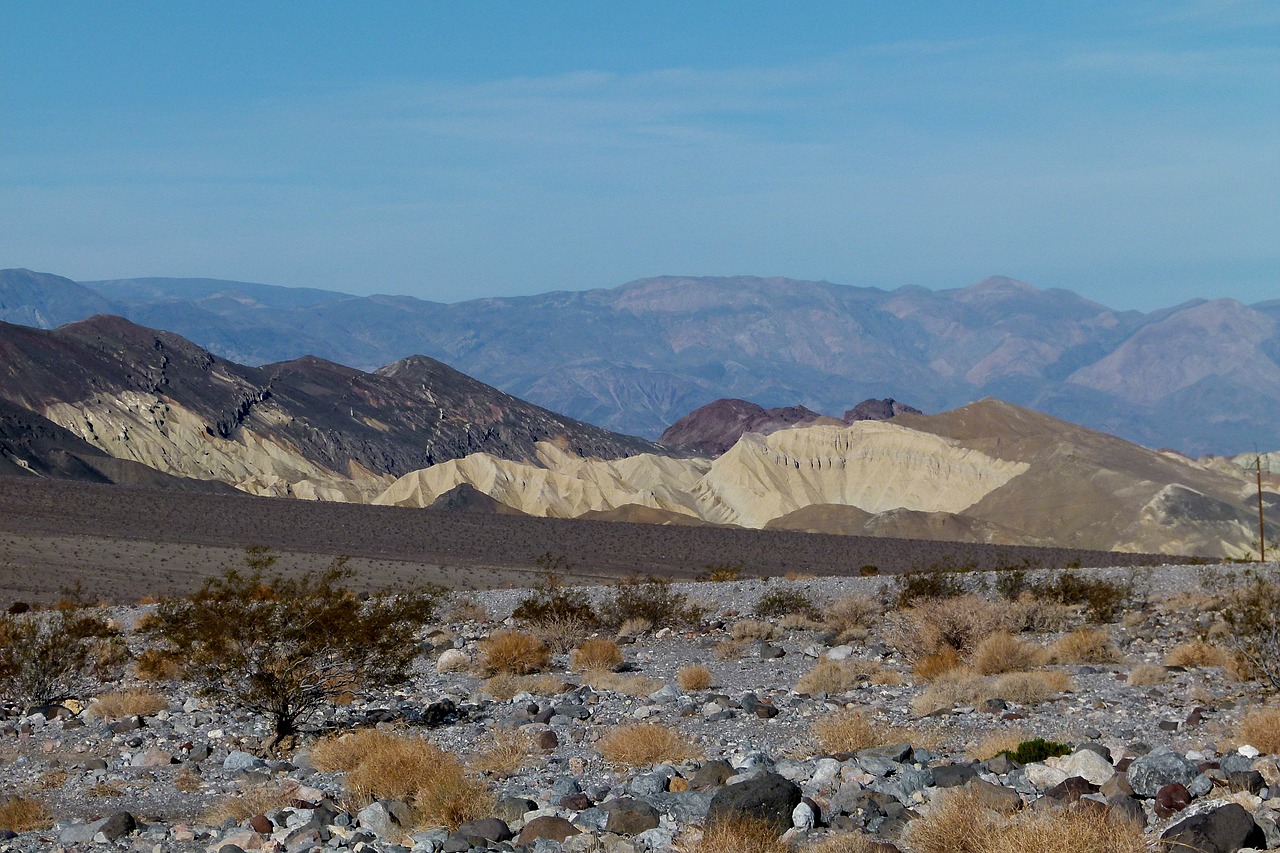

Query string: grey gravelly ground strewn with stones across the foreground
0 558 1280 853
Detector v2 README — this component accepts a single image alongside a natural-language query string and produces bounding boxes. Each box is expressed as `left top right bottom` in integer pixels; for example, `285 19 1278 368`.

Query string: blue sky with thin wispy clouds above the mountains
0 0 1280 310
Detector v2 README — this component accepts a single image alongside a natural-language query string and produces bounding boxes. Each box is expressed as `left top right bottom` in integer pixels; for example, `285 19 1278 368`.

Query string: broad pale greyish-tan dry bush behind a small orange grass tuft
884 596 1009 662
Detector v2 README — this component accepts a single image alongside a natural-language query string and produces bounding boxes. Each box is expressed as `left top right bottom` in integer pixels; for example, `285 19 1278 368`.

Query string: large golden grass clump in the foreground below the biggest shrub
311 729 493 829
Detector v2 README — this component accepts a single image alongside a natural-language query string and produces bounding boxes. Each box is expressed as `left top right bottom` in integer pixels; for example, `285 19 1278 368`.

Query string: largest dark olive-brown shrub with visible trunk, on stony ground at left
145 549 440 745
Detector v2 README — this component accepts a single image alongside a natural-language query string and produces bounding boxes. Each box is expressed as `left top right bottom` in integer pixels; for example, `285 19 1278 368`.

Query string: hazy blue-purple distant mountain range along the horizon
0 270 1280 455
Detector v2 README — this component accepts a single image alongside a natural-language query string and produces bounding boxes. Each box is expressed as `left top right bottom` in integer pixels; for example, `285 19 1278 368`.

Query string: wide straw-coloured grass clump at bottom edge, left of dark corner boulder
908 788 1146 853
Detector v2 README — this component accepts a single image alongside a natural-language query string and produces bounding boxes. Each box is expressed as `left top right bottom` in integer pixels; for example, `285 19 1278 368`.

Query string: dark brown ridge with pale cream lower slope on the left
0 315 662 500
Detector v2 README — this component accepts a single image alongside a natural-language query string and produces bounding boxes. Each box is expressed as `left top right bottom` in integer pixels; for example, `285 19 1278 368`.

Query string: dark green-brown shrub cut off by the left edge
0 606 119 704
